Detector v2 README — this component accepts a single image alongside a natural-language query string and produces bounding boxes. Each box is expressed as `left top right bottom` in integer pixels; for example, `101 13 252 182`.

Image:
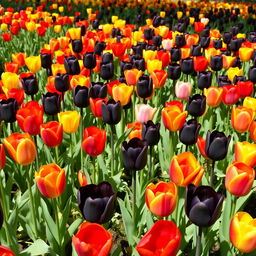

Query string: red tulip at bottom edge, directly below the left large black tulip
72 222 113 256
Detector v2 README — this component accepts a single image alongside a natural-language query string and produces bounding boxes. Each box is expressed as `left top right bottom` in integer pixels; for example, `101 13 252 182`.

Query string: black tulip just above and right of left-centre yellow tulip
72 85 90 108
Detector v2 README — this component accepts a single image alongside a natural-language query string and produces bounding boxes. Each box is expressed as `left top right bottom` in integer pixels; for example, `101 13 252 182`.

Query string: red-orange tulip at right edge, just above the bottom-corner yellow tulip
225 162 255 196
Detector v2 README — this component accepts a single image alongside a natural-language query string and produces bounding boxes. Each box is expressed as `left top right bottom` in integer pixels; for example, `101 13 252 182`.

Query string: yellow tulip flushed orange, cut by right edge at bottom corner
229 212 256 253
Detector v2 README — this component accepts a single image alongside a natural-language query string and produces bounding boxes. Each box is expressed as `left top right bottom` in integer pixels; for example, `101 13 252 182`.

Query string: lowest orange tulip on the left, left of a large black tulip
35 163 66 198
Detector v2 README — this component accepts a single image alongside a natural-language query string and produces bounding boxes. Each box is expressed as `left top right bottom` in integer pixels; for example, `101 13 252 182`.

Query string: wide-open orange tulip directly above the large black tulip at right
170 152 204 187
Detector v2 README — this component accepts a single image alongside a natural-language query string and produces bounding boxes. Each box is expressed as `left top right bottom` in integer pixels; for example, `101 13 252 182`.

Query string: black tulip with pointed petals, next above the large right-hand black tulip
205 131 231 161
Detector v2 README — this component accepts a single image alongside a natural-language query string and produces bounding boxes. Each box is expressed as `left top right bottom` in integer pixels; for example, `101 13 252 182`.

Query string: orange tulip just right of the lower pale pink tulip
162 105 188 132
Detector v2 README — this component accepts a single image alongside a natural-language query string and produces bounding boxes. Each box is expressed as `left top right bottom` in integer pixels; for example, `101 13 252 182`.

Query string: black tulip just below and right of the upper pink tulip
188 94 206 117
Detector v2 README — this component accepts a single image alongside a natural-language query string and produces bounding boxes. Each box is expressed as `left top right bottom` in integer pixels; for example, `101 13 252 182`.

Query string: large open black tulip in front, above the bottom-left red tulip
77 181 116 224
